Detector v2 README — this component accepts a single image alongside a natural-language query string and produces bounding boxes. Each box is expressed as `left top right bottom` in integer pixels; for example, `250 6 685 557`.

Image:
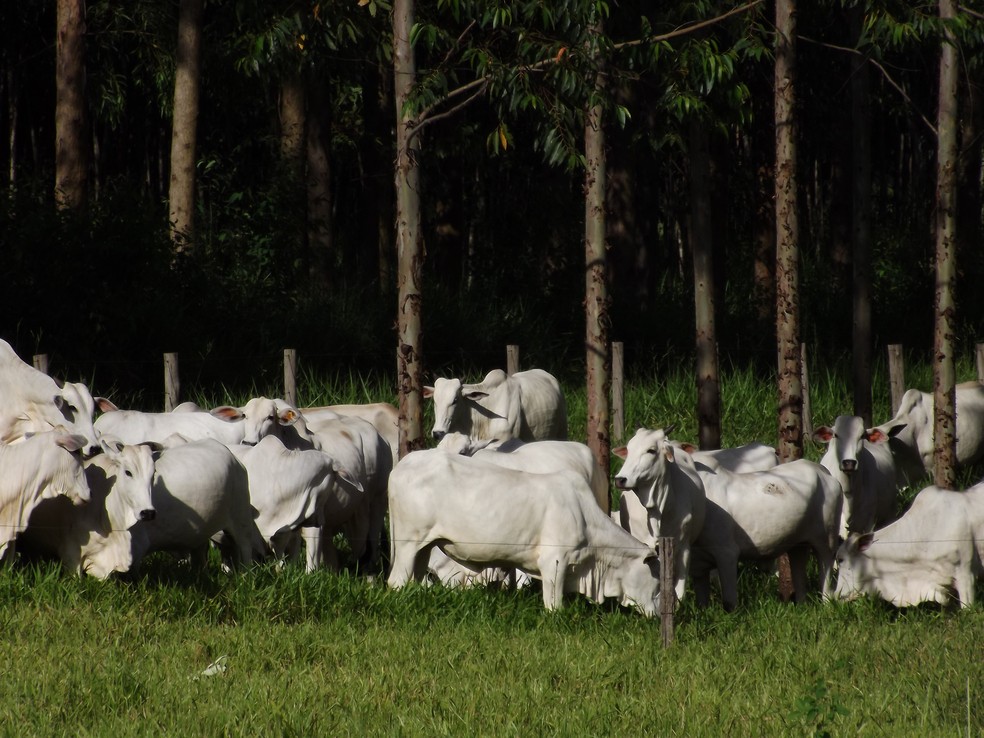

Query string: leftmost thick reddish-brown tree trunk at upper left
55 0 89 210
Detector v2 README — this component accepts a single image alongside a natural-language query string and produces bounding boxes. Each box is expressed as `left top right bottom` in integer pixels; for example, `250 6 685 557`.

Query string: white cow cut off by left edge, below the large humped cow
0 431 89 561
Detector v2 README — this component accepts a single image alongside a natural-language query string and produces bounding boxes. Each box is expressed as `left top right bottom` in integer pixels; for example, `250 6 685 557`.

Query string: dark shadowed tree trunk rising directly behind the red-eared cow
851 8 873 427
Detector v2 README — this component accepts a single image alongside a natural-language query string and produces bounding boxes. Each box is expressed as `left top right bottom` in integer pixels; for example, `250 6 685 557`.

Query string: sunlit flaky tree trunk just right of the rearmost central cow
584 59 611 513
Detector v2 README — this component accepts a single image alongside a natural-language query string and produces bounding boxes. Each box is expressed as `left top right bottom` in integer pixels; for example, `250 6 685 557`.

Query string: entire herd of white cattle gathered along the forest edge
0 340 984 616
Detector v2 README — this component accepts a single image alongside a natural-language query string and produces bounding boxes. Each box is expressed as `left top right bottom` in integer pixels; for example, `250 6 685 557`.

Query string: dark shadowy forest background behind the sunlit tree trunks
0 0 984 402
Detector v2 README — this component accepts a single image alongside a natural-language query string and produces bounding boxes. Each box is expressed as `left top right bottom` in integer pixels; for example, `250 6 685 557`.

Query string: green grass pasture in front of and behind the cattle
0 356 984 737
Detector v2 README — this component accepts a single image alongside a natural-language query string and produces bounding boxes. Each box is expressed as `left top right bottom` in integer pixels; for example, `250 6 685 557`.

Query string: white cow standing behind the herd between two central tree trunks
424 369 567 441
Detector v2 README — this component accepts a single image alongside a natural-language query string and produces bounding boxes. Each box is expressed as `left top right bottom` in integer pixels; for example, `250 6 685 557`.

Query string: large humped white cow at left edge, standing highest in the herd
0 340 99 456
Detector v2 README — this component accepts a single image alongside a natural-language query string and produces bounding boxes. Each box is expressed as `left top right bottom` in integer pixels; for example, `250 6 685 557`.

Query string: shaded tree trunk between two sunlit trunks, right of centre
690 119 721 449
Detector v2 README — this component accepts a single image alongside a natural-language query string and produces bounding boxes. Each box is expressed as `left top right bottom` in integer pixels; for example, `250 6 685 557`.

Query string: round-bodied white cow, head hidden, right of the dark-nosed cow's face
128 436 268 568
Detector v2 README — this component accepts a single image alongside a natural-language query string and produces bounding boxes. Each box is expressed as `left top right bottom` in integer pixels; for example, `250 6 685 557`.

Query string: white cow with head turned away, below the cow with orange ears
230 436 369 571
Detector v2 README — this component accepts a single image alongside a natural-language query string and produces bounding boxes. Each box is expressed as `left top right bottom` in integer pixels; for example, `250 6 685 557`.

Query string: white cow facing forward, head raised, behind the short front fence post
612 426 707 602
